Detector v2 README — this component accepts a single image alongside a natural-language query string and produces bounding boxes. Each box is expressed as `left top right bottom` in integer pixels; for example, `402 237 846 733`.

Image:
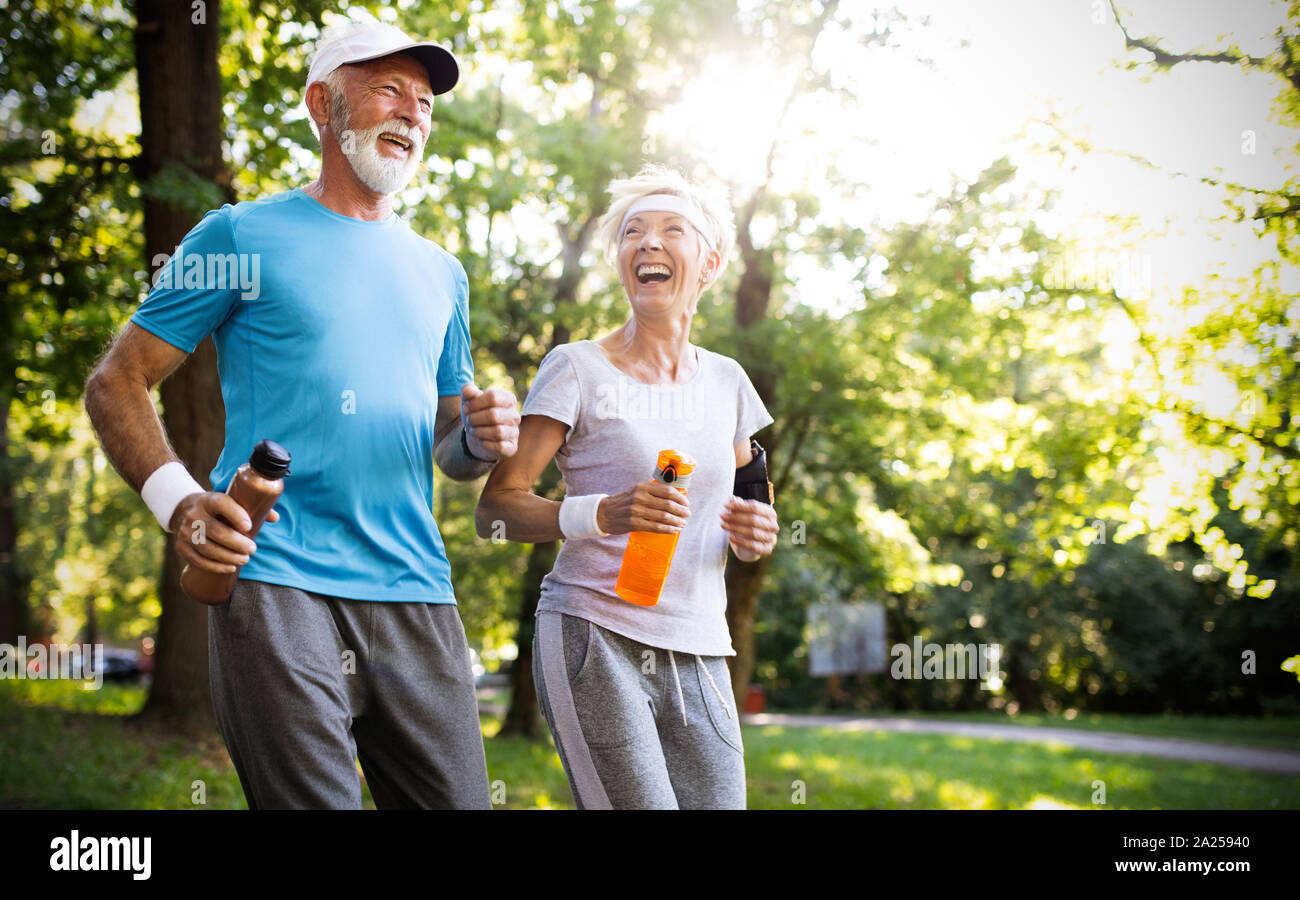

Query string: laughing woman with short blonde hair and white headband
476 166 777 809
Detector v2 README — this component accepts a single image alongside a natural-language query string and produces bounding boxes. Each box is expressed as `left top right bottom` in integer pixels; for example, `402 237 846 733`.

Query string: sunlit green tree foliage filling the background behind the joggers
0 0 1300 713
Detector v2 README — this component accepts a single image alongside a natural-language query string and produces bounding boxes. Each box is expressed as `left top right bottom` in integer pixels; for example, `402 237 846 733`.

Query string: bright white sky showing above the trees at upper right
655 0 1300 304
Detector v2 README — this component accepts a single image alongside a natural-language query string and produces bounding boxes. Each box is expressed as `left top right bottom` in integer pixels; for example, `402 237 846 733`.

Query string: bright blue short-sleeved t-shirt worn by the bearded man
131 190 473 603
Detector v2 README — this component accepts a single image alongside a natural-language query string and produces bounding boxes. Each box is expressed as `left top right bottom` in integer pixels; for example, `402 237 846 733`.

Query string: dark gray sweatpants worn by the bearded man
208 580 491 809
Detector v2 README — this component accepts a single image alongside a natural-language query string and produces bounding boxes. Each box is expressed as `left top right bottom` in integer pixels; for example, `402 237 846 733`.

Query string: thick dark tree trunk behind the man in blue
135 0 229 727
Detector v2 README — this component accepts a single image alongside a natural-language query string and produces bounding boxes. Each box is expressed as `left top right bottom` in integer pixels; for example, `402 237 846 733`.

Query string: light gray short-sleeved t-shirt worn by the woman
520 341 772 657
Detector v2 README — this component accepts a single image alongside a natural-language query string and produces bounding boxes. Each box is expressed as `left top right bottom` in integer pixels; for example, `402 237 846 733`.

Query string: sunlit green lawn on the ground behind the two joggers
0 680 1300 809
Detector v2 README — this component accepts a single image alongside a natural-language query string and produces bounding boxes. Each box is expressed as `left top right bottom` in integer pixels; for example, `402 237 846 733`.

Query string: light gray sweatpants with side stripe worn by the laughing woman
533 613 745 809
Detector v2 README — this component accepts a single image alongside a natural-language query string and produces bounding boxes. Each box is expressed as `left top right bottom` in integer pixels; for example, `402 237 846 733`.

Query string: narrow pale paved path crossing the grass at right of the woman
745 713 1300 775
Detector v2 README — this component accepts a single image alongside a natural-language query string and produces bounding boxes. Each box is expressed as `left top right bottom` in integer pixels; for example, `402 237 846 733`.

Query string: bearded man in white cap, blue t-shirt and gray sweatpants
78 23 519 808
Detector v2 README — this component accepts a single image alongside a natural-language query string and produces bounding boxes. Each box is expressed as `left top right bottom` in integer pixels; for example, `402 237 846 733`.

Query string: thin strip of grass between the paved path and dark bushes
768 709 1300 752
